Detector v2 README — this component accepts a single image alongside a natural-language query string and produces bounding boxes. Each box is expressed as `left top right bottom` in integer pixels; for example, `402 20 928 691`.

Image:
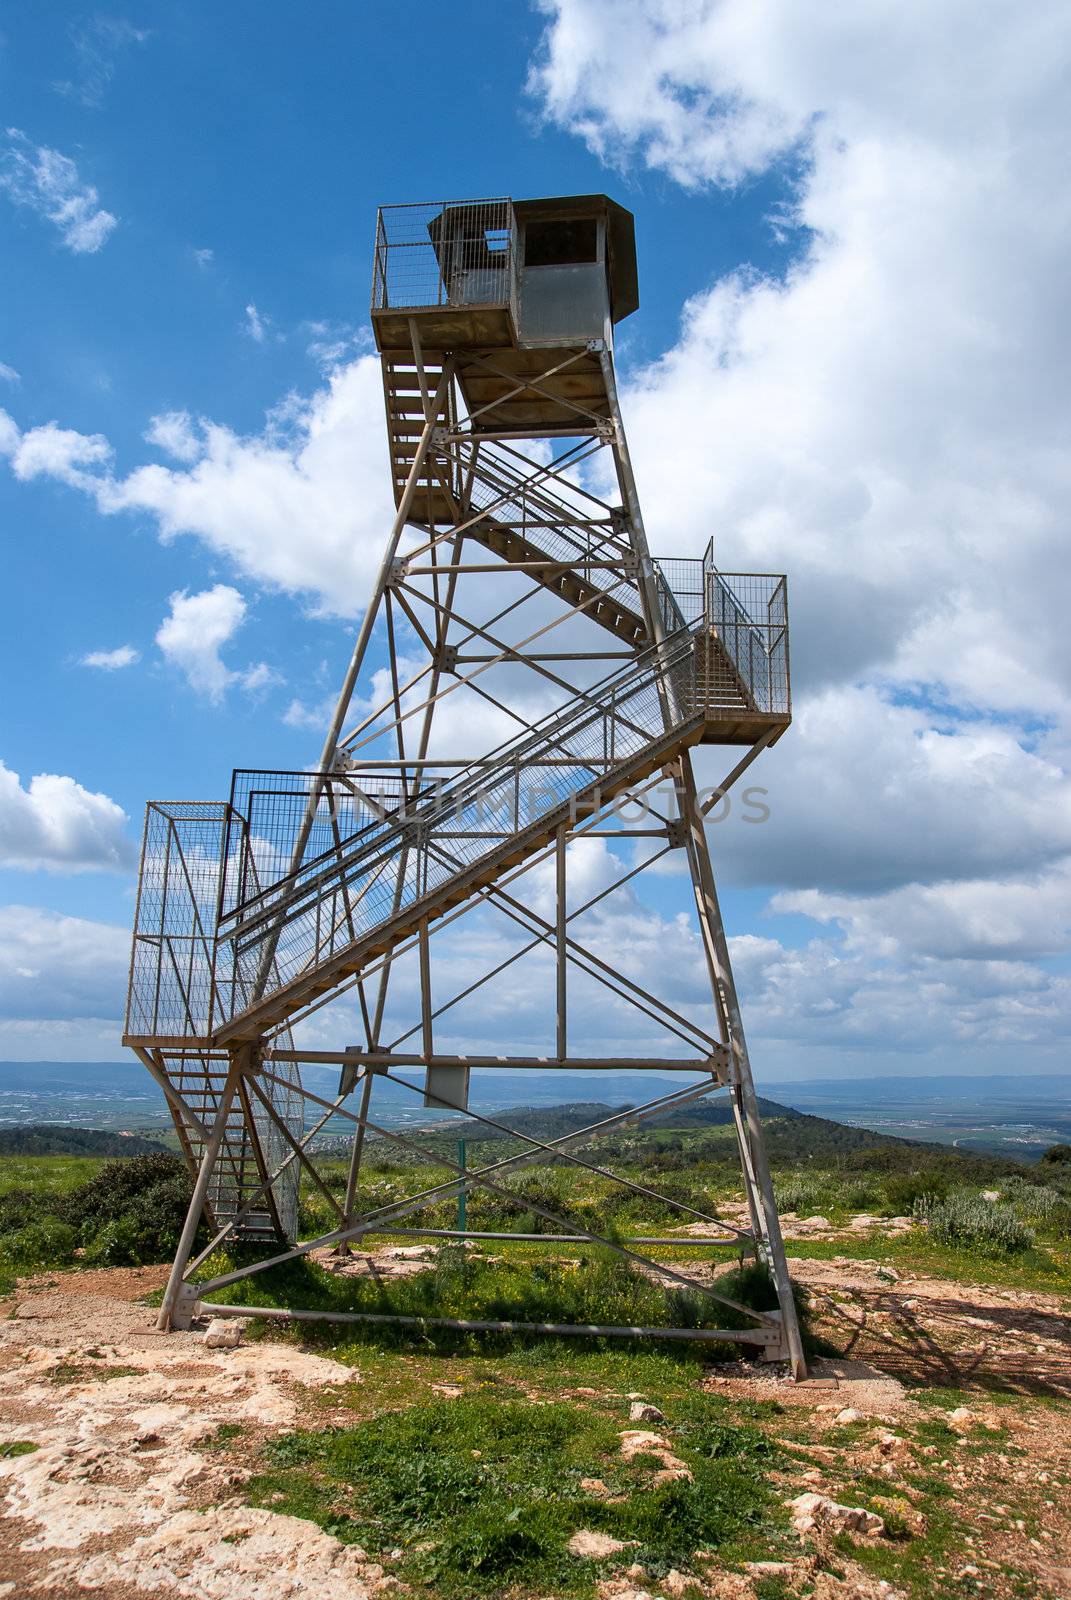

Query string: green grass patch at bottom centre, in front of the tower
248 1394 788 1600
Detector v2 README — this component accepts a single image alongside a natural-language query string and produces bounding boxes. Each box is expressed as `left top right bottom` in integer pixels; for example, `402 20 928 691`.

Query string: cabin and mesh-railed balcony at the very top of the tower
371 195 639 352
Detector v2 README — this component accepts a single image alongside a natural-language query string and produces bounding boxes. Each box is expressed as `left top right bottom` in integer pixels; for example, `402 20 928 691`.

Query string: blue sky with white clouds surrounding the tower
0 0 1071 1077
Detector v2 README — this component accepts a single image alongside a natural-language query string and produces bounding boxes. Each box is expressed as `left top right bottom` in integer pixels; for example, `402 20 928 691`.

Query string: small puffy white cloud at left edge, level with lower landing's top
0 762 134 872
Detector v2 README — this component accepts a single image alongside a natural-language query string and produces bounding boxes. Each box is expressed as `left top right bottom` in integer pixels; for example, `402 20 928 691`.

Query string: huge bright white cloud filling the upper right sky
531 0 1071 714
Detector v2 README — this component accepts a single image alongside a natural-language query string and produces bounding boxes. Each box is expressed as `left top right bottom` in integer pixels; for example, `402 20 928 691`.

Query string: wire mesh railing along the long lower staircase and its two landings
126 552 789 1040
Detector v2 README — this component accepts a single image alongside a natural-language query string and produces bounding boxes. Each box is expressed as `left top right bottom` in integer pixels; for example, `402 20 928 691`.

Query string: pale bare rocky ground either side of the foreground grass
0 1253 1071 1600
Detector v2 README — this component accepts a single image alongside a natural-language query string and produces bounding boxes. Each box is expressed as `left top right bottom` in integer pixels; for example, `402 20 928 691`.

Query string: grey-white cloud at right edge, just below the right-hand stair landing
698 686 1071 893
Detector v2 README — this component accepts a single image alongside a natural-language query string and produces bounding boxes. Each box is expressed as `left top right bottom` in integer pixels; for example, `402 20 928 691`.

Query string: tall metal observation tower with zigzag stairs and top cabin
125 195 804 1374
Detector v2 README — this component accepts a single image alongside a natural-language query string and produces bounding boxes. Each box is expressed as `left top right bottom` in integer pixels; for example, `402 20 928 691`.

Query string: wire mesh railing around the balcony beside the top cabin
371 198 515 312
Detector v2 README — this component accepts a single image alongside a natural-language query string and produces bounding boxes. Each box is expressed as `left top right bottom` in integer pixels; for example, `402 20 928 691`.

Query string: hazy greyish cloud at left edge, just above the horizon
0 906 130 1017
